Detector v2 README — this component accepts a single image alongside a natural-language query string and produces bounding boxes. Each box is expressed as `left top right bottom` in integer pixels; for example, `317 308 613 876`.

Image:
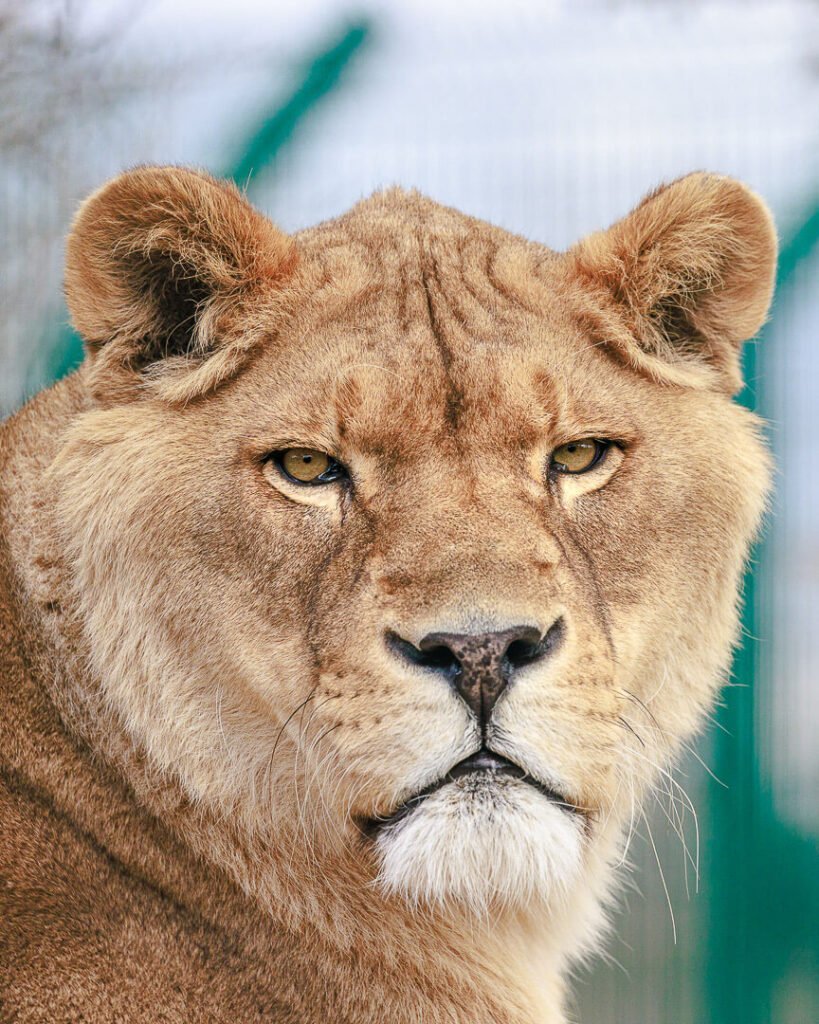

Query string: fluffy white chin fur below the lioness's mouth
376 773 583 913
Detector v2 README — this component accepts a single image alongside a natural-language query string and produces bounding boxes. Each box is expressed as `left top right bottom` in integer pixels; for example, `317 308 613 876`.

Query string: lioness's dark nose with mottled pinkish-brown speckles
388 618 563 726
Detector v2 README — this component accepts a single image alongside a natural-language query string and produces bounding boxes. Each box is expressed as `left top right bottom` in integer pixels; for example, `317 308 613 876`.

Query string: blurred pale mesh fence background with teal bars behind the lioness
0 0 819 1024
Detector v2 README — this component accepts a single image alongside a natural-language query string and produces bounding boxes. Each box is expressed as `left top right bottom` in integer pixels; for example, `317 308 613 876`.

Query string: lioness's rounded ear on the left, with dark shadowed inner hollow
66 167 296 400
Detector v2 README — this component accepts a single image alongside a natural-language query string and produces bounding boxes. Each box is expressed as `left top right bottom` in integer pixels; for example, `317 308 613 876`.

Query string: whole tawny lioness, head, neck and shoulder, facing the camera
0 167 776 1024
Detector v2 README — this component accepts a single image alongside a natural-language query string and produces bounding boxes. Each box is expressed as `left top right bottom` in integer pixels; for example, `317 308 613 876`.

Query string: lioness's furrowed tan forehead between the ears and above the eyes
243 209 629 459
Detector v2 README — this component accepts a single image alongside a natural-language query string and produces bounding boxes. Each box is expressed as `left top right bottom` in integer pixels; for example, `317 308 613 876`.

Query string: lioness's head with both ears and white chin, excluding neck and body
48 169 774 912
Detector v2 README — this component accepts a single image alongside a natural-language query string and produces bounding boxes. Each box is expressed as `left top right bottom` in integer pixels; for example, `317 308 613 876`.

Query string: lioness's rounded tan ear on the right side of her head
569 173 776 392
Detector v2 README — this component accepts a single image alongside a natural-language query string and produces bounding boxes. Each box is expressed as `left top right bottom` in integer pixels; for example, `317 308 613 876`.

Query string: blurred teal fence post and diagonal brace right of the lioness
703 197 819 1024
